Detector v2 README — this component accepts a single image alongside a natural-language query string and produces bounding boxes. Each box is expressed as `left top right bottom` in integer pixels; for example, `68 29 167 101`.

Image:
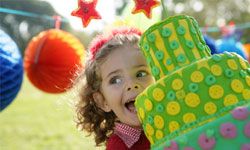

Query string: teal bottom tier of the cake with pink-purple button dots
151 103 250 150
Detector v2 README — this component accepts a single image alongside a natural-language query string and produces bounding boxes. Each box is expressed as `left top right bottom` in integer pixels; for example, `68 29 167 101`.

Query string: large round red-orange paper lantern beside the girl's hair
24 29 85 93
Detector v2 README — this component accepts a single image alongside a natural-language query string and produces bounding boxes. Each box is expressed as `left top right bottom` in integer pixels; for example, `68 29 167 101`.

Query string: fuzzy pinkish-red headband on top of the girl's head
89 27 142 60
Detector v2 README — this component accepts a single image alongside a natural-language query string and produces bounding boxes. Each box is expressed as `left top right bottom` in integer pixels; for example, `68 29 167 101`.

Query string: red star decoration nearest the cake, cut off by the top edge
132 0 160 18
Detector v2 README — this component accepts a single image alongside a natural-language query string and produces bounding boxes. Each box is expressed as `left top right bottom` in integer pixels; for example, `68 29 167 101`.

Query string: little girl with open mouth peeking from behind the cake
73 28 154 150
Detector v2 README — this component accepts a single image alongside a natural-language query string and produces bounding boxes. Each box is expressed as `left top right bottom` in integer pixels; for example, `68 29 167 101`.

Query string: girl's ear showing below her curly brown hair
93 92 111 112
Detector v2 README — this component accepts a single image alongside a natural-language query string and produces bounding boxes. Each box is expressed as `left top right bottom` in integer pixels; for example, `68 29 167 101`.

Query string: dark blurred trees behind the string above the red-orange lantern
0 0 88 54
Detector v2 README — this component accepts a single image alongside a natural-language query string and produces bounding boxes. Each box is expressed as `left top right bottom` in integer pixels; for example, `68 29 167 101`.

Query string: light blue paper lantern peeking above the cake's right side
216 38 247 59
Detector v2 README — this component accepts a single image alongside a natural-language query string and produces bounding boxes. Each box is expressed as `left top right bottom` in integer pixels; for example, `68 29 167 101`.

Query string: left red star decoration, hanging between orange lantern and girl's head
71 0 101 27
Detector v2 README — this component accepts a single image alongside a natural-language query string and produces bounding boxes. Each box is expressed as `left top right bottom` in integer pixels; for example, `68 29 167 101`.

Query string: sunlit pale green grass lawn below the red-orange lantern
0 75 104 150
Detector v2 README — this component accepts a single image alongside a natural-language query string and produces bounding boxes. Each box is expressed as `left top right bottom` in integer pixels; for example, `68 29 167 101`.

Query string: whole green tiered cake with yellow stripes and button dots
135 15 250 150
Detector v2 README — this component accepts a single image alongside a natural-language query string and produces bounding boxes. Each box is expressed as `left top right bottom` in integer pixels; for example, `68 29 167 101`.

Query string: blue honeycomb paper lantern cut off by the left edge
0 30 23 111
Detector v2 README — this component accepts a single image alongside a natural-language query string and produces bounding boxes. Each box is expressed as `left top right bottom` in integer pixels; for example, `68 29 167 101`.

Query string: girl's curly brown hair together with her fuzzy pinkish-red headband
75 28 141 146
